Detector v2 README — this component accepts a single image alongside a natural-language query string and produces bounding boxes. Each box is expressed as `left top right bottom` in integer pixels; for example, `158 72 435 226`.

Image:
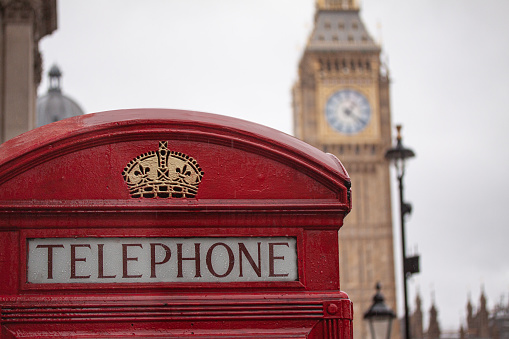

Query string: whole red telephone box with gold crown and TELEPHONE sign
0 109 353 338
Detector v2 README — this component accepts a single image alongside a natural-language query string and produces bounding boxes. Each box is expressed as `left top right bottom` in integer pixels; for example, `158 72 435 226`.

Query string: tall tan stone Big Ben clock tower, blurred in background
293 0 399 338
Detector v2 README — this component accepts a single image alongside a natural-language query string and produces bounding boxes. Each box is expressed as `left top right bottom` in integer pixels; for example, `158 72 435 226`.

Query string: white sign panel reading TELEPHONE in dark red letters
27 237 298 284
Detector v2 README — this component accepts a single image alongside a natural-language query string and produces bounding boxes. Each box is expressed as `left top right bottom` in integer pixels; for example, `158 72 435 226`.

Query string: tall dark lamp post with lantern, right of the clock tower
385 125 419 339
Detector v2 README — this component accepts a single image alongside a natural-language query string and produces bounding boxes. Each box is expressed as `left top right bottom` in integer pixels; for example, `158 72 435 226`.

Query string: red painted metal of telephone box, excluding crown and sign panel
0 109 353 338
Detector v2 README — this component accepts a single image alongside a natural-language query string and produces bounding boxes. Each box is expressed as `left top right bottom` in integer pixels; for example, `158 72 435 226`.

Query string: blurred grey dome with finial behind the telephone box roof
37 65 84 127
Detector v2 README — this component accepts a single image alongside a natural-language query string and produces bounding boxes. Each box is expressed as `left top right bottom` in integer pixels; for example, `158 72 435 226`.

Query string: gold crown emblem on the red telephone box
122 141 203 198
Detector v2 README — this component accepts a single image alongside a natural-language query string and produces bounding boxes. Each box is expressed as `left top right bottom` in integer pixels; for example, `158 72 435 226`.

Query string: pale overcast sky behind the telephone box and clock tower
39 0 509 330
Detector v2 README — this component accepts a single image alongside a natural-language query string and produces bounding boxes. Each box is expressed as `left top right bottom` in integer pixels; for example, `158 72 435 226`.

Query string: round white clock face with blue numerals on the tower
325 89 371 134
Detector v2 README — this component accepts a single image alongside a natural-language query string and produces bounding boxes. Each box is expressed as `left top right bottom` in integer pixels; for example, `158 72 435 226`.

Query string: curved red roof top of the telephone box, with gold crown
0 109 350 205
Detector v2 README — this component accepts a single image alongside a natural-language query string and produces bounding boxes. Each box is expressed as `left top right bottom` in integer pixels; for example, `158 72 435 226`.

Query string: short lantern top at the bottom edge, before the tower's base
364 283 396 339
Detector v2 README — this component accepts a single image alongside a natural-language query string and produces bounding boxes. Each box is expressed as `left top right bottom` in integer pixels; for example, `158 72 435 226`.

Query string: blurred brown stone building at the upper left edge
0 0 57 143
